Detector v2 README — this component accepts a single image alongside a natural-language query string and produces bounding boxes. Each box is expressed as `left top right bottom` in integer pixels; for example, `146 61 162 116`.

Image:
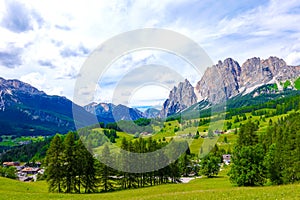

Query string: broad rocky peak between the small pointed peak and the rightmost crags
195 58 241 102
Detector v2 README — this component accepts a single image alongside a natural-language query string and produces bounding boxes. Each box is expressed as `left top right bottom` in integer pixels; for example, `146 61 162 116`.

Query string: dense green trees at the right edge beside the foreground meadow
229 113 300 186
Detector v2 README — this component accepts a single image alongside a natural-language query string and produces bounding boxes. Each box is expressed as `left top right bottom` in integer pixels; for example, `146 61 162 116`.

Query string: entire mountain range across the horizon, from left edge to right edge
0 57 300 135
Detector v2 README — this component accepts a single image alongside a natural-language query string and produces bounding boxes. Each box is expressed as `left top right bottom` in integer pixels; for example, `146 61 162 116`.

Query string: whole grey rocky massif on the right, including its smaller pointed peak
160 57 300 117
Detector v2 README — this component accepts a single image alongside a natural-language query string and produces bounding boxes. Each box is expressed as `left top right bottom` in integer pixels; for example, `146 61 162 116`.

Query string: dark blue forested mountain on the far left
0 78 94 135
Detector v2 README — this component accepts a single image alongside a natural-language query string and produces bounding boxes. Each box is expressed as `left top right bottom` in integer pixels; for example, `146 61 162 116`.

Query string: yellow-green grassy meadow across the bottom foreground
0 173 300 200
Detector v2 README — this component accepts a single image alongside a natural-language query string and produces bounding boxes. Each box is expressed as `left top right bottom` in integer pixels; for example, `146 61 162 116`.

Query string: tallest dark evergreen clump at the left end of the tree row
45 132 97 193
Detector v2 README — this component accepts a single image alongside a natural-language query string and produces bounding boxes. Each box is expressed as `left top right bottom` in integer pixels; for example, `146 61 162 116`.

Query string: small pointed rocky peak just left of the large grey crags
160 79 197 117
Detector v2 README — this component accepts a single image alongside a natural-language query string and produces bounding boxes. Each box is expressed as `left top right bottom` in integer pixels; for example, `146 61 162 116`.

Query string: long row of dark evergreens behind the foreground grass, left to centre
45 132 190 193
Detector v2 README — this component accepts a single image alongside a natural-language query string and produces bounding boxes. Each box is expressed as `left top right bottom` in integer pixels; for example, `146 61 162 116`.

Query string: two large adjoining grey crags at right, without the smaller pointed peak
195 57 300 103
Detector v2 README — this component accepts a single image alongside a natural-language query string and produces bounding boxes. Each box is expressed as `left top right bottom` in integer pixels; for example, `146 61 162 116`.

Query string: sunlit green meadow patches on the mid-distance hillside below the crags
89 109 294 156
